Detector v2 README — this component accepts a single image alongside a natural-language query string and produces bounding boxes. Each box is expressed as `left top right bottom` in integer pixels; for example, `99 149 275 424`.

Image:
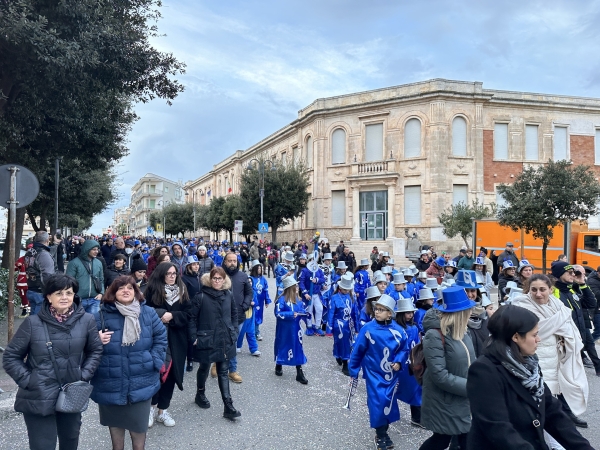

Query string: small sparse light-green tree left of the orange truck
438 200 496 247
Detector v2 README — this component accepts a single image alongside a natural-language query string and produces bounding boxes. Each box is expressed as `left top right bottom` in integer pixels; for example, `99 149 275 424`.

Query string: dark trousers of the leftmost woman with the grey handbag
23 412 81 450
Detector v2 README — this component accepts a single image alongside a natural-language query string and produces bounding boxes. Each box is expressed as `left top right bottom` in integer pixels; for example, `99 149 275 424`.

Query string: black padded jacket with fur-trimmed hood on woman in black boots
193 273 238 364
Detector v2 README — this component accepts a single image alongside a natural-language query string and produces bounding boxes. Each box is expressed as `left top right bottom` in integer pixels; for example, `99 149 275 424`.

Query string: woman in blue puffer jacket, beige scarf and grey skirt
92 276 167 450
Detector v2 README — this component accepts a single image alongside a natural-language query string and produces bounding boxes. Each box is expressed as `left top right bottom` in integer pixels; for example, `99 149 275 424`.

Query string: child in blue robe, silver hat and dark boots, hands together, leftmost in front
274 277 308 384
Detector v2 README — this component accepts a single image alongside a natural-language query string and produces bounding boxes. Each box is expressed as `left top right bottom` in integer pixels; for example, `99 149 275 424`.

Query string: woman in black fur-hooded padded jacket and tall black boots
192 266 241 420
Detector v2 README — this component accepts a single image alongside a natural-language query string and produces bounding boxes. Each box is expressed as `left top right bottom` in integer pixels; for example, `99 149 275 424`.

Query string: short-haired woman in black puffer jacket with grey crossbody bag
3 274 102 450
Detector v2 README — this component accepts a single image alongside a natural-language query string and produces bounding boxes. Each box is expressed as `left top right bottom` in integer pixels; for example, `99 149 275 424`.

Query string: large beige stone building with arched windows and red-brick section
184 79 600 257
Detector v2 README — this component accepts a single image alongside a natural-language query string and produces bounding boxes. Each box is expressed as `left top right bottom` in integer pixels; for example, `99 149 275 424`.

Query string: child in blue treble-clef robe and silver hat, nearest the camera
348 295 409 449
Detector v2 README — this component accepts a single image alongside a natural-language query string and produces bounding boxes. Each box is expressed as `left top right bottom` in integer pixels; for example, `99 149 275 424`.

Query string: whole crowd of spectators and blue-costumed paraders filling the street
3 231 600 450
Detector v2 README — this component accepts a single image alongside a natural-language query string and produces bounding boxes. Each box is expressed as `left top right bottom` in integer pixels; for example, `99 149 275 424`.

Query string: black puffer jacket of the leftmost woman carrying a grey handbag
2 297 103 416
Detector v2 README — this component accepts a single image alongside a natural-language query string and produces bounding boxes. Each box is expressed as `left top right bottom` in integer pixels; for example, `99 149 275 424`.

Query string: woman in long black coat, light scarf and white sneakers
145 263 195 427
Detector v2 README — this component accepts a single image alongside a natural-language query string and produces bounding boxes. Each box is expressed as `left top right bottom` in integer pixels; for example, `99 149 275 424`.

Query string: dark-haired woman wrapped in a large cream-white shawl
512 274 588 438
